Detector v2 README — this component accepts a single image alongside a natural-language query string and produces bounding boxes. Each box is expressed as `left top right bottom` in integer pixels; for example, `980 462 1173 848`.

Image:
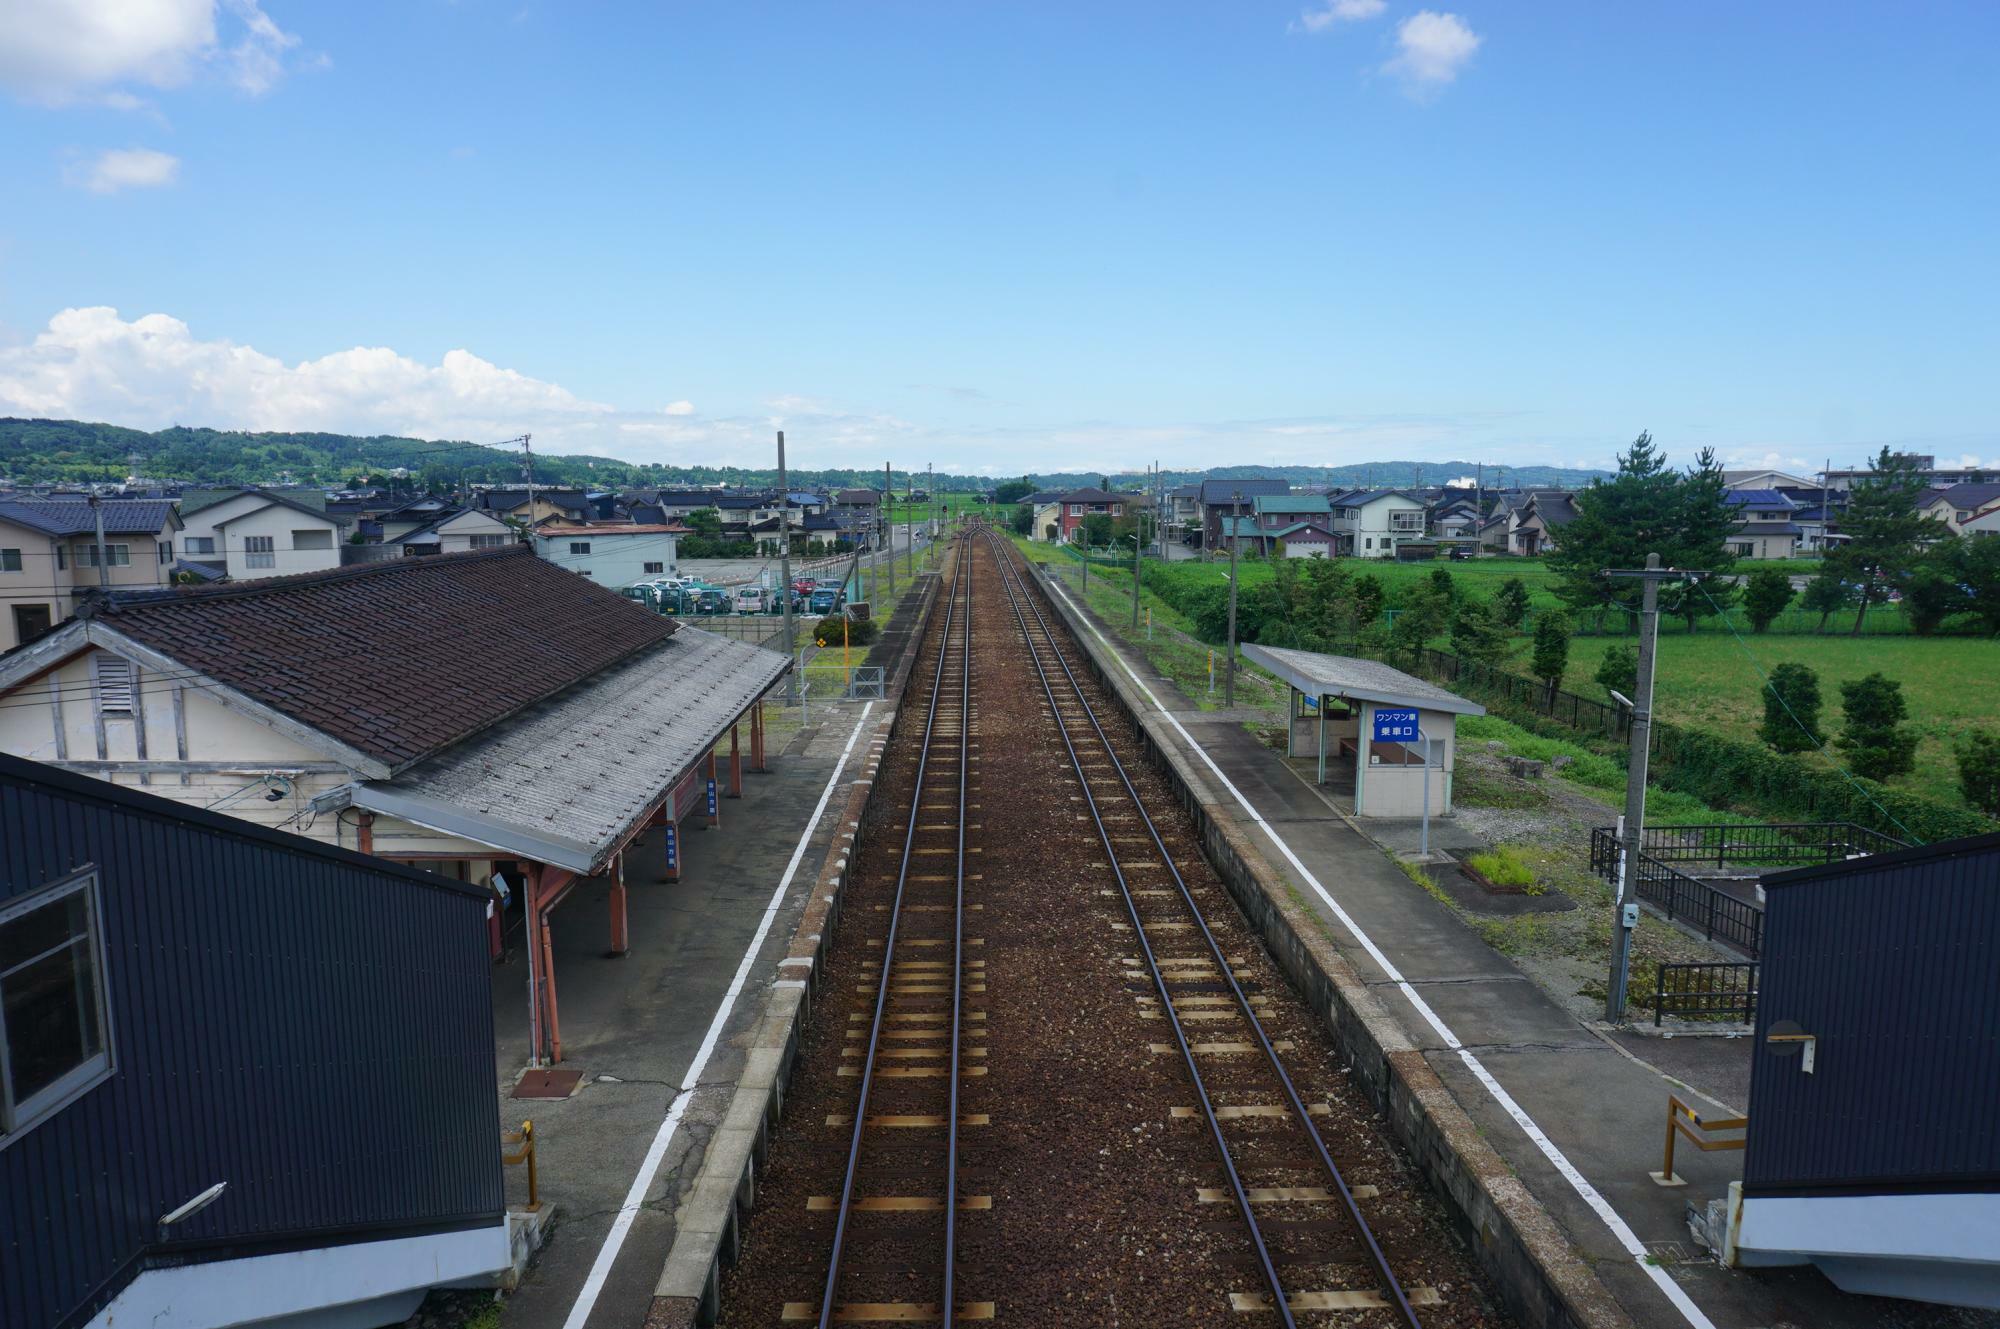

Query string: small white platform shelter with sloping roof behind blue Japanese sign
1242 644 1486 817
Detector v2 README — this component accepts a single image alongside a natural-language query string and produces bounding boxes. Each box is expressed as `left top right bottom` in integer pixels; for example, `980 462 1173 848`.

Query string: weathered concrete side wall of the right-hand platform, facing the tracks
1046 560 1632 1329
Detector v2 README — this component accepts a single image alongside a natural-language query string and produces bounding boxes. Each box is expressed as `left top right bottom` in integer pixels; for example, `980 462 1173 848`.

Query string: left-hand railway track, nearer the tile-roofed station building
784 540 994 1329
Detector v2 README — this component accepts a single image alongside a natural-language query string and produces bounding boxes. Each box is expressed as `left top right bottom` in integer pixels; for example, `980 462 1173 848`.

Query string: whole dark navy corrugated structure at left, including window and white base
0 752 528 1329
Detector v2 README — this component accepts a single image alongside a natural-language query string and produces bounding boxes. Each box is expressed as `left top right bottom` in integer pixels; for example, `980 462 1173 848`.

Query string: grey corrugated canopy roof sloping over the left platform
354 626 790 873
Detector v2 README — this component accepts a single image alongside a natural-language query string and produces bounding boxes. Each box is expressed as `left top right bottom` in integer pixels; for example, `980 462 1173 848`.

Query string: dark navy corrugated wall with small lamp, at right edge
1744 835 2000 1195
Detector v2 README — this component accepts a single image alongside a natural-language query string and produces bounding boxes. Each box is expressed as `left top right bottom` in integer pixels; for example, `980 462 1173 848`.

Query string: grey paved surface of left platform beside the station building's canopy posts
494 705 880 1329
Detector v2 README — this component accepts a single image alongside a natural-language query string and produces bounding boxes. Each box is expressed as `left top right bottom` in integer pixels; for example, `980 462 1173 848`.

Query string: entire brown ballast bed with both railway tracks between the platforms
722 526 1506 1329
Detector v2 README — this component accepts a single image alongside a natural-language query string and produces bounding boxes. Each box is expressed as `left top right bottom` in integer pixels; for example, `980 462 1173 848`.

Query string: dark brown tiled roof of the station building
86 544 674 769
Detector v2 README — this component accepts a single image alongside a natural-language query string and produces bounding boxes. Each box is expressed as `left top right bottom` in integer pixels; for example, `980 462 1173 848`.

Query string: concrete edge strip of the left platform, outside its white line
644 574 940 1329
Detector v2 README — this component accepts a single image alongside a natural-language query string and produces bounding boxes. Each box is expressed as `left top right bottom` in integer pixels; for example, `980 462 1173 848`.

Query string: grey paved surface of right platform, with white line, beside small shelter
1040 580 1984 1329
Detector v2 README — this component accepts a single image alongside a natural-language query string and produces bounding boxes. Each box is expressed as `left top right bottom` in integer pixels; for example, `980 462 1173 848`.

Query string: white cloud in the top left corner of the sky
0 0 298 110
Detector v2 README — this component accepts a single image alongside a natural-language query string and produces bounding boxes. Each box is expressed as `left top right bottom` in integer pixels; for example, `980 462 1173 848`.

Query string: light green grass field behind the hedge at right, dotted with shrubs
1512 630 2000 805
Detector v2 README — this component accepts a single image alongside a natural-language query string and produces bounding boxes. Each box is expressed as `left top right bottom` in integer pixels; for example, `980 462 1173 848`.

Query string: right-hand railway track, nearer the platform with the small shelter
980 532 1430 1329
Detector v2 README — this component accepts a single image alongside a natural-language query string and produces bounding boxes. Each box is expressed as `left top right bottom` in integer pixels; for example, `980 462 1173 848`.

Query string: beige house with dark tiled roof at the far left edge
0 498 180 650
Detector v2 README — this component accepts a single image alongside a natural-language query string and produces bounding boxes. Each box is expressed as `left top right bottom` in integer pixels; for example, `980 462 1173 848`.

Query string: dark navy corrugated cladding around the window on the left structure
0 757 506 1327
